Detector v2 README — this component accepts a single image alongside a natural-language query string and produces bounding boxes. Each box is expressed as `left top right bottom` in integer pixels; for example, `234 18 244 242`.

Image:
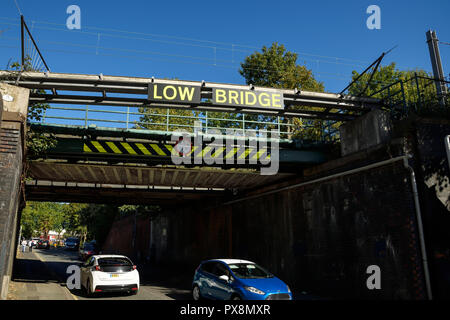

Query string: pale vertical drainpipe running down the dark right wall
403 155 433 300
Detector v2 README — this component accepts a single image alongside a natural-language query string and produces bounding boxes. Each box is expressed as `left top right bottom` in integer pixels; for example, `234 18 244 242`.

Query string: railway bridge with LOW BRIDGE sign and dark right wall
0 71 447 299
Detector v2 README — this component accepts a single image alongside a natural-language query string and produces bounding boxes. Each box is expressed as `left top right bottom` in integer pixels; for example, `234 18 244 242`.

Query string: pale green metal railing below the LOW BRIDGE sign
30 105 339 142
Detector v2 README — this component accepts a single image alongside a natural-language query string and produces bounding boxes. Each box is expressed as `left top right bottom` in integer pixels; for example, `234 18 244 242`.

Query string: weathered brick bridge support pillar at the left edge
0 83 29 300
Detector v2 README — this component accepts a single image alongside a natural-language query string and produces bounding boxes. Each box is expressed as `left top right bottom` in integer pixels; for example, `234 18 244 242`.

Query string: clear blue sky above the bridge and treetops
0 0 450 92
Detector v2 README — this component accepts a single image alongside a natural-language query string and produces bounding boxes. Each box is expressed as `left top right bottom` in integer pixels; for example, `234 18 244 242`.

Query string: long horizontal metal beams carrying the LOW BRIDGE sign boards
0 71 381 121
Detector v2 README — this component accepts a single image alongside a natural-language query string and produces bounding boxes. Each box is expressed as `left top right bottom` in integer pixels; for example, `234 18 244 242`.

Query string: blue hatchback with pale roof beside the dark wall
192 259 292 300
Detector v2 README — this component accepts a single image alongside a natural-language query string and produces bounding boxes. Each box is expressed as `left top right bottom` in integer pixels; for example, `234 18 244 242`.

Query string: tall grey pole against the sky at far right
426 30 447 106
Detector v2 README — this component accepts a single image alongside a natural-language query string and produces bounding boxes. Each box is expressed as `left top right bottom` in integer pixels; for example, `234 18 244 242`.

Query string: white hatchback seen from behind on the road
80 254 139 295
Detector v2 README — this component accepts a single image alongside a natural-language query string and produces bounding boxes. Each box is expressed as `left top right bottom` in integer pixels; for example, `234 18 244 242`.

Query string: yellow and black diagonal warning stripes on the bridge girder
83 140 270 161
